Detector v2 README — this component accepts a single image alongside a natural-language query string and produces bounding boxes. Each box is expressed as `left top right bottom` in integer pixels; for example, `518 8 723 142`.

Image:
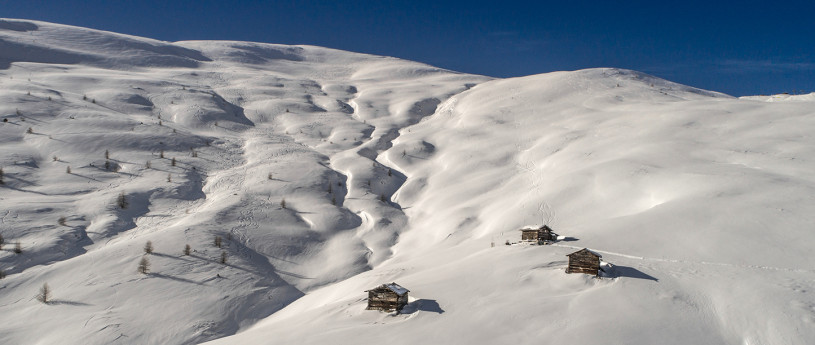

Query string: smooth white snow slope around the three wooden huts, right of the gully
215 69 815 344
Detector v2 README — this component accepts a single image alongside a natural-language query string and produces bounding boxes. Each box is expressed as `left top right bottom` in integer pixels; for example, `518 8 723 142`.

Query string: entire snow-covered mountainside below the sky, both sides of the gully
0 19 815 344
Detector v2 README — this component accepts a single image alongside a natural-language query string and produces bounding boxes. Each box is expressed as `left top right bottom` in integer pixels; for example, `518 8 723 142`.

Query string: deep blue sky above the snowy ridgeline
0 0 815 96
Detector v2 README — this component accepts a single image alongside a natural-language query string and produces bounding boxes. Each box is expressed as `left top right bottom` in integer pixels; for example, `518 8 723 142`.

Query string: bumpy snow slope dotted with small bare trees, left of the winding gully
0 20 488 344
